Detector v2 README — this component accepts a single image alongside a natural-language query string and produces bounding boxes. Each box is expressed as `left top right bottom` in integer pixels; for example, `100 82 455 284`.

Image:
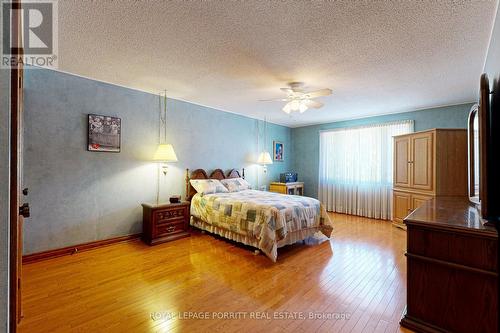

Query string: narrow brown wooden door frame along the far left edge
8 2 23 332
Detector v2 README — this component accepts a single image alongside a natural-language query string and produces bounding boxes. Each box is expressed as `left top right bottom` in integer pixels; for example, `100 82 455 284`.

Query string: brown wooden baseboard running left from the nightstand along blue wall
23 233 142 264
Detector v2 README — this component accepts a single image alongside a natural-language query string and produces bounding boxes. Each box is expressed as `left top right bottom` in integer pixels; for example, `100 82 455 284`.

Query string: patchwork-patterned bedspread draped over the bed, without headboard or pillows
191 190 332 261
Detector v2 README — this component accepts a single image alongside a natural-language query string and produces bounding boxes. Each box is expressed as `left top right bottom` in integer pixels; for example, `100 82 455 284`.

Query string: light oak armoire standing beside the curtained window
392 129 468 229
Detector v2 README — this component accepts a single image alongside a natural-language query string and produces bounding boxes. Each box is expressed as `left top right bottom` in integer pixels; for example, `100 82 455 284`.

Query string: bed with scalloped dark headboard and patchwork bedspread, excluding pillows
186 169 333 262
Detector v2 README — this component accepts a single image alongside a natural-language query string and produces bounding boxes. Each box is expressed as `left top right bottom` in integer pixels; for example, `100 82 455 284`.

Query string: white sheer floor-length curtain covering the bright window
318 120 414 220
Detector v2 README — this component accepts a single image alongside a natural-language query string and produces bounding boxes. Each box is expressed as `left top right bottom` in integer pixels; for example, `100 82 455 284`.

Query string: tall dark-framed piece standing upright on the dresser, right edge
468 74 500 225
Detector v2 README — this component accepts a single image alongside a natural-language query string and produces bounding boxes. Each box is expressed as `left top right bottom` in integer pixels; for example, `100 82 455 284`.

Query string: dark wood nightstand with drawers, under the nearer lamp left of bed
142 202 190 245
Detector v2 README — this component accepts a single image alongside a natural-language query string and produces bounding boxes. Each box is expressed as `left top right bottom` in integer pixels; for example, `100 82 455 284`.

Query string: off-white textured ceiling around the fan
59 0 496 127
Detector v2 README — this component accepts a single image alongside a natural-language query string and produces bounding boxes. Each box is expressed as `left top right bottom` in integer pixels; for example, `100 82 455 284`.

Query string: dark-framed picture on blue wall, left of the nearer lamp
87 114 122 153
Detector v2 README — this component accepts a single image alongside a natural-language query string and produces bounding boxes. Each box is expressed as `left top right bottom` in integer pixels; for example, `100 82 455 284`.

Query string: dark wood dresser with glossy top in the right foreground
401 197 498 333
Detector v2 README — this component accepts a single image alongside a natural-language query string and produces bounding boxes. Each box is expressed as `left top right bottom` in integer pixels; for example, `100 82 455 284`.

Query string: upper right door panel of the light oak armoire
410 132 434 191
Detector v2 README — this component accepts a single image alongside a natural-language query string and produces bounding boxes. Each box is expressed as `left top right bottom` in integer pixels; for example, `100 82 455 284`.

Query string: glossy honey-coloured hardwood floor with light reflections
20 214 408 332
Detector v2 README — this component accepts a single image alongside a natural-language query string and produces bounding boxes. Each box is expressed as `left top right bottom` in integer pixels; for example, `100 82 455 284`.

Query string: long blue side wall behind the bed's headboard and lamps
24 69 291 254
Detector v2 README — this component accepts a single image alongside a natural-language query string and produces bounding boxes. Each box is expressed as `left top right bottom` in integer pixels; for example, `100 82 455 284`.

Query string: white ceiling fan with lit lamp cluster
263 82 332 114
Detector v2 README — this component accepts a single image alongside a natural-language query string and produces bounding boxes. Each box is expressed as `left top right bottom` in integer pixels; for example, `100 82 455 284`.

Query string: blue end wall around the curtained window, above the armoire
292 104 472 198
